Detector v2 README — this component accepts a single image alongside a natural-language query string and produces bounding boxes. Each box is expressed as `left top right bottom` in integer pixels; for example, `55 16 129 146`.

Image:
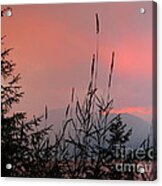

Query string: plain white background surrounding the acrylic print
0 0 162 186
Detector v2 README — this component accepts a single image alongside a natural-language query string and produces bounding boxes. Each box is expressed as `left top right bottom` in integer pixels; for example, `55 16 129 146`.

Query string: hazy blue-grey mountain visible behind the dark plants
42 108 152 148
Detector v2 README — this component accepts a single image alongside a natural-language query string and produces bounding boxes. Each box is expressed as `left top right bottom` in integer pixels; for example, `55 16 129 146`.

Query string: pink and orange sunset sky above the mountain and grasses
2 1 152 121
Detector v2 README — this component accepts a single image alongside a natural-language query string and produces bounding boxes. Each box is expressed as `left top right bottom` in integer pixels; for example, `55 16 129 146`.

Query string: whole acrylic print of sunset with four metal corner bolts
1 1 157 180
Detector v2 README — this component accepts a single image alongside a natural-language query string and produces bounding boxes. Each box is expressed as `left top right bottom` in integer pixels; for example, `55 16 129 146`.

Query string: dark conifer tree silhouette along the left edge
1 9 53 177
